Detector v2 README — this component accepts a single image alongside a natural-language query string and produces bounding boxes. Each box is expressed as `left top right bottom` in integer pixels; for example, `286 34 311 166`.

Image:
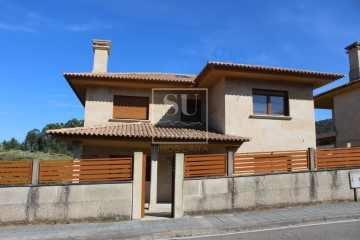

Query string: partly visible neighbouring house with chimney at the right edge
314 42 360 147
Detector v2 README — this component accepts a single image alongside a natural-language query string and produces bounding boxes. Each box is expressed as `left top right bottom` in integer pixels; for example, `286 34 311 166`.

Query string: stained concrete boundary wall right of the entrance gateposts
183 169 360 215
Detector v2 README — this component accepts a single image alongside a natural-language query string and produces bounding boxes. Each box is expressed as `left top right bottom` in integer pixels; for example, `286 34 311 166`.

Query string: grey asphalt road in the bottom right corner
176 221 360 240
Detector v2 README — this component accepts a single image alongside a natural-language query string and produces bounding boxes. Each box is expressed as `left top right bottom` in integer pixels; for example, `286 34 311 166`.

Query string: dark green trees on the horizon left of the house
3 118 84 155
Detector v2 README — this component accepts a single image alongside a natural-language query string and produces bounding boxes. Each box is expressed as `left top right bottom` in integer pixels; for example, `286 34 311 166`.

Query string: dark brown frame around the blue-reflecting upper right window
253 89 290 116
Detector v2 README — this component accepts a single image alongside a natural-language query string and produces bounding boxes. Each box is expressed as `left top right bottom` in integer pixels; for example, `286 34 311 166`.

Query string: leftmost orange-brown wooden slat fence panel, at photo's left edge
0 161 32 185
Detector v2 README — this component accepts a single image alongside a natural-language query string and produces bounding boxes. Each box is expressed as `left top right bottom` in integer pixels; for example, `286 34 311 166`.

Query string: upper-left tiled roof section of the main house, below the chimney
63 72 195 83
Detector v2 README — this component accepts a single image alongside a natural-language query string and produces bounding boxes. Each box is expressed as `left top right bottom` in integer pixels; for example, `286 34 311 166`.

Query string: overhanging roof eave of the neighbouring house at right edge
314 79 360 109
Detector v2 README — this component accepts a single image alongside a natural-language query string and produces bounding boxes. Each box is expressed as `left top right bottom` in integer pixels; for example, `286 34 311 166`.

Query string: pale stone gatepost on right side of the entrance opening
173 153 184 218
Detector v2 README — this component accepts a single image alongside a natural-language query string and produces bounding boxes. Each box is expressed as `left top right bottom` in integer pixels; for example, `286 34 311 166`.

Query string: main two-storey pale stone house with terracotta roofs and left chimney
48 40 344 204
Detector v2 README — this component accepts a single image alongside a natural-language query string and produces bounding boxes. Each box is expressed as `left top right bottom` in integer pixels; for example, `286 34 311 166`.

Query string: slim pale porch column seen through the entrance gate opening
149 145 159 210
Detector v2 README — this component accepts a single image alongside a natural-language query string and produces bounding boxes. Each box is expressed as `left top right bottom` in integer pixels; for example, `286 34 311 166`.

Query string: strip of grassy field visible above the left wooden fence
0 150 72 160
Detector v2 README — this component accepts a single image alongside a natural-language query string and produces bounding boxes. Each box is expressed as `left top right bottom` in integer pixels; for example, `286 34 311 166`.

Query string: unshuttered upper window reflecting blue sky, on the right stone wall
253 89 289 116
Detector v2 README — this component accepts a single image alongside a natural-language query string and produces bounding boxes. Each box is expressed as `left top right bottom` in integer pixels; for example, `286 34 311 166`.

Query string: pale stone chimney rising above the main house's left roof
93 39 111 72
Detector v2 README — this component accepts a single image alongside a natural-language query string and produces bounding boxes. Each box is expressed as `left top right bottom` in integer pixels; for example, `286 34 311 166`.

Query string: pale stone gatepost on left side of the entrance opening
132 152 143 219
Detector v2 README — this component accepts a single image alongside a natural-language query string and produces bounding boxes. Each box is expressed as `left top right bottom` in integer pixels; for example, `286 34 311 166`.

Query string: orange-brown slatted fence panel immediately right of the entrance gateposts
184 154 226 177
